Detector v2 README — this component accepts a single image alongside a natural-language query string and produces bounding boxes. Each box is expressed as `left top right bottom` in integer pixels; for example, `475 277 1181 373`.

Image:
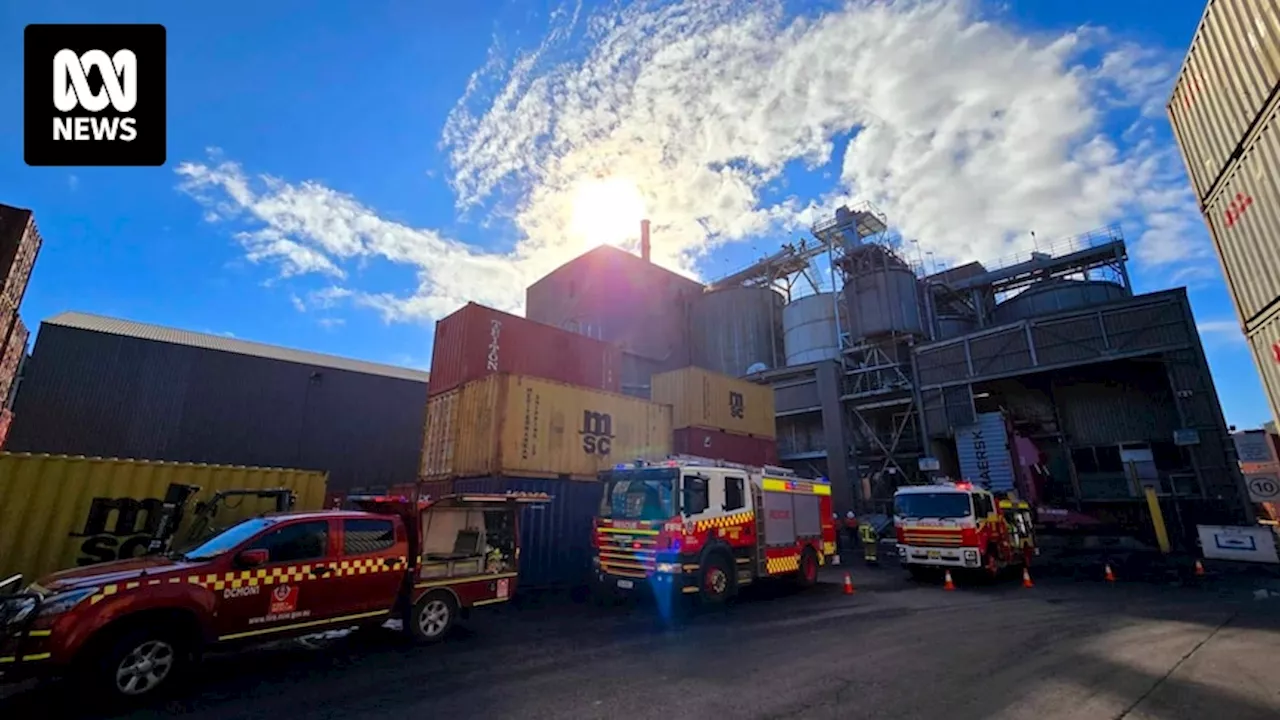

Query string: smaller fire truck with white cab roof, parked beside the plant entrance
893 483 1038 578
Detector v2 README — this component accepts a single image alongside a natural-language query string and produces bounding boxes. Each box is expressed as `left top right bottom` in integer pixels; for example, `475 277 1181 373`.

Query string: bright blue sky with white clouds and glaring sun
0 0 1268 427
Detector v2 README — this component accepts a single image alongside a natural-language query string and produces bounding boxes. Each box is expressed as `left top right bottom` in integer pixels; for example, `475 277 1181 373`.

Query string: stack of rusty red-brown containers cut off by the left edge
0 205 42 447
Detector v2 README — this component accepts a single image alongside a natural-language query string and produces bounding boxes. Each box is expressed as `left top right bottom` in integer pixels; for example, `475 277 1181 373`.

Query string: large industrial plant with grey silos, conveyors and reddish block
529 198 1251 537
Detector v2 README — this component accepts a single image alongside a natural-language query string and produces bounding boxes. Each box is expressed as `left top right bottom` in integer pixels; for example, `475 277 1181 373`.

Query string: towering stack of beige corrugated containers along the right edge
1169 0 1280 420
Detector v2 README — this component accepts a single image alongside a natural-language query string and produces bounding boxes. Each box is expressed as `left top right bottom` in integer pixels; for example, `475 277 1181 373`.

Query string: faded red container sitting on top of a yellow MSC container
428 302 622 397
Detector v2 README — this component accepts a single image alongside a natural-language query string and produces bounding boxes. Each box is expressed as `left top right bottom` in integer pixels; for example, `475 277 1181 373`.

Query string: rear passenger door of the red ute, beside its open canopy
337 516 408 615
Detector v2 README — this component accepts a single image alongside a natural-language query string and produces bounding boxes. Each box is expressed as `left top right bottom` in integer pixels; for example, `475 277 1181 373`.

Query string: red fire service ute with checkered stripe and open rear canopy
0 495 550 700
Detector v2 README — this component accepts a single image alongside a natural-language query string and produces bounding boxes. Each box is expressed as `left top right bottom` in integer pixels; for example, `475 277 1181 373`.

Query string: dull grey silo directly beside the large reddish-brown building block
690 287 783 377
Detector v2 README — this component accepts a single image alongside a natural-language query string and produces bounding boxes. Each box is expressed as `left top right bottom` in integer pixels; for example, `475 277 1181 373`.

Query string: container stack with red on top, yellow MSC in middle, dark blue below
420 304 672 588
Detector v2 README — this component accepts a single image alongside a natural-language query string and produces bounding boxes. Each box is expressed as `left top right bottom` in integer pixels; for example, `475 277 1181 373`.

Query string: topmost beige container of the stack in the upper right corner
1169 0 1280 200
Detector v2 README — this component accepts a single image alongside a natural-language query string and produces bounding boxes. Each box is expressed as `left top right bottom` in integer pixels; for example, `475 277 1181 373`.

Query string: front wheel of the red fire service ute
87 624 191 703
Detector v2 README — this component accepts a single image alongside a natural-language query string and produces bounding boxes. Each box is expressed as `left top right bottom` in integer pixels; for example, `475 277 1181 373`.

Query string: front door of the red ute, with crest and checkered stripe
216 519 342 641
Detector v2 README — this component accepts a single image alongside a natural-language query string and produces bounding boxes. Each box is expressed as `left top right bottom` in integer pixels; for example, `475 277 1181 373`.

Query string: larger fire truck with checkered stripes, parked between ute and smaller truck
593 456 836 603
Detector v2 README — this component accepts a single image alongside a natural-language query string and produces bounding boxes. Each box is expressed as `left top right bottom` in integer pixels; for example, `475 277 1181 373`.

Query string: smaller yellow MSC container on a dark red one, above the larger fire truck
653 366 778 465
